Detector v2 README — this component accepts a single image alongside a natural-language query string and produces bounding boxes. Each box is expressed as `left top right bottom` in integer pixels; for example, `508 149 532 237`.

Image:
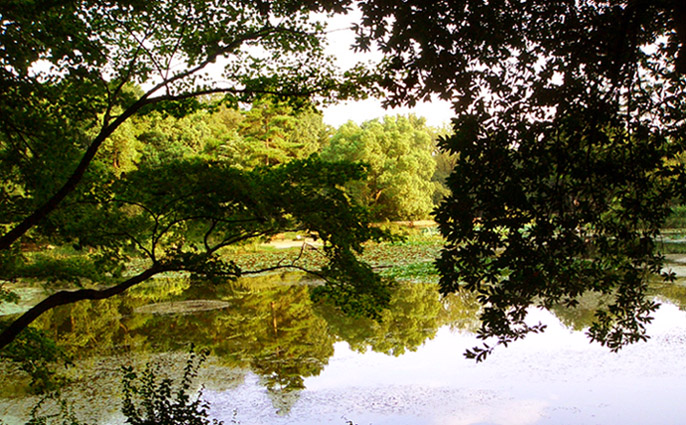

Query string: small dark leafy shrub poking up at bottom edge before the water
122 350 223 425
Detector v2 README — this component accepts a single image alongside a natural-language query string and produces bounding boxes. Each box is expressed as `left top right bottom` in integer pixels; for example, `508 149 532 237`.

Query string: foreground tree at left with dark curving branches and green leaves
0 0 383 348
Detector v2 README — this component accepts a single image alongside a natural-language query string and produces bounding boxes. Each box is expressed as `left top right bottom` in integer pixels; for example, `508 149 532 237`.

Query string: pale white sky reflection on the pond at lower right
206 304 686 425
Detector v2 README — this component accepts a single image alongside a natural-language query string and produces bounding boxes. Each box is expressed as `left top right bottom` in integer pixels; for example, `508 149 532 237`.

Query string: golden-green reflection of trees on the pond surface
2 274 686 420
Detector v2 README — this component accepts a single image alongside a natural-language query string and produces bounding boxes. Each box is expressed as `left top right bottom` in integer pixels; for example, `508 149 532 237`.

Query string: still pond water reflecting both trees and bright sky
0 268 686 425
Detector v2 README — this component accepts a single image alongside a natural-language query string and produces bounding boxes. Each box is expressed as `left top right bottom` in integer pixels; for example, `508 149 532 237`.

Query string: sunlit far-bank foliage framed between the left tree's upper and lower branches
134 96 330 169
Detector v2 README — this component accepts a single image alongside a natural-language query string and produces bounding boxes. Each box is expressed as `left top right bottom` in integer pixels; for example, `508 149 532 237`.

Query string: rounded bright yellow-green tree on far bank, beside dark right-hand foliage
322 116 436 220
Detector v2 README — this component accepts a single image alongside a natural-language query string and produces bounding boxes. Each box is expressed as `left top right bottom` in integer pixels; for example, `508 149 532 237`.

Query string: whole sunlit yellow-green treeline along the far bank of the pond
99 94 454 220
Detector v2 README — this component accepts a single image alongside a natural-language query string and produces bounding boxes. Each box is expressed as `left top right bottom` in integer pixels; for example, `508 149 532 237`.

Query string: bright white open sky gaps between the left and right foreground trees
323 11 453 127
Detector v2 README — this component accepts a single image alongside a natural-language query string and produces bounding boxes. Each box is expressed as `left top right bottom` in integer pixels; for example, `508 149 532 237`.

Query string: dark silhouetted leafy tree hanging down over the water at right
357 0 686 360
